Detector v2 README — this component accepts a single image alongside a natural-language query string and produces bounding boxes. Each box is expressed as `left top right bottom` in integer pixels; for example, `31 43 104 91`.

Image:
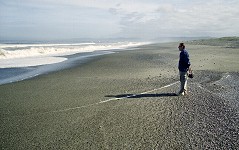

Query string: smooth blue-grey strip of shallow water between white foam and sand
0 50 113 85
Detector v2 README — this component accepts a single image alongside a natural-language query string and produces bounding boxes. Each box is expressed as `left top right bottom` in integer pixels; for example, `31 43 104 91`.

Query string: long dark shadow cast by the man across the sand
105 93 177 98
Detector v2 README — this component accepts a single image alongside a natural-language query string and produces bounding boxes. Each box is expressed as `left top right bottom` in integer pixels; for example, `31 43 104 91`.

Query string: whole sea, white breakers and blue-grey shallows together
0 42 146 85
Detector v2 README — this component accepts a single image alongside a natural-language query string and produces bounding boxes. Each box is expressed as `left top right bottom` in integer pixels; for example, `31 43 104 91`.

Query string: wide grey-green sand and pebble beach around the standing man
0 39 239 149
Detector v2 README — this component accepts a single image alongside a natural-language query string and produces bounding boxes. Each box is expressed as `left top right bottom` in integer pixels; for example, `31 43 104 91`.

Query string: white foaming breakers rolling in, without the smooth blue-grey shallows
0 42 146 68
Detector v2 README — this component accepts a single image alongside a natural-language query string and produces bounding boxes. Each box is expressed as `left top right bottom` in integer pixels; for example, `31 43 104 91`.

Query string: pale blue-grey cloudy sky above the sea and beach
0 0 239 40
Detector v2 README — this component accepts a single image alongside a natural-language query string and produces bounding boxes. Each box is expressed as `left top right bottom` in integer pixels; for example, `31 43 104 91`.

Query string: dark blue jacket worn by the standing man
178 49 190 72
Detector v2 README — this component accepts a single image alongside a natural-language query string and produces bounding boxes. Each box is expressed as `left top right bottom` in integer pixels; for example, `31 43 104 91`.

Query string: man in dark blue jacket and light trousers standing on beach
177 43 190 95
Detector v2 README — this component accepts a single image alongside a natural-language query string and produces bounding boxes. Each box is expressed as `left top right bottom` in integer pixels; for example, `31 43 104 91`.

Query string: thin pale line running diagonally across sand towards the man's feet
48 81 179 113
